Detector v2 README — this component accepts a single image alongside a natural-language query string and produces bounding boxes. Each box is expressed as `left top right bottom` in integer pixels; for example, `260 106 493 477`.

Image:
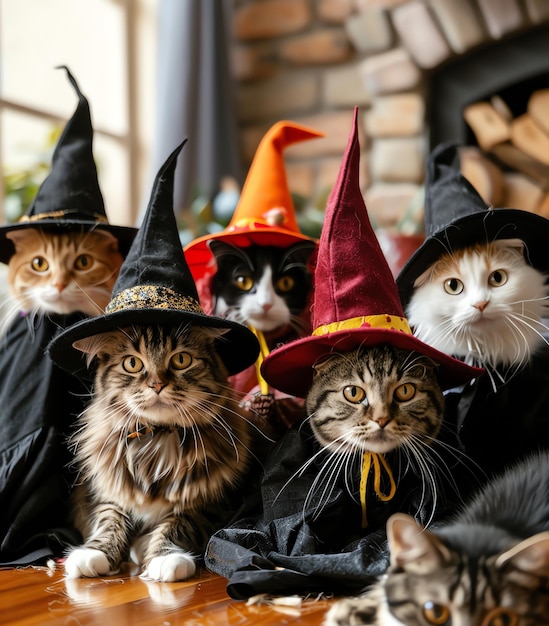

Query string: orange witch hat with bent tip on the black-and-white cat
185 120 324 281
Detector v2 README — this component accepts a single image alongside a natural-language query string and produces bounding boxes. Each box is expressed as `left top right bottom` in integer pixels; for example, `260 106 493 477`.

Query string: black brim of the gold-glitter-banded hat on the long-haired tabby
47 309 259 376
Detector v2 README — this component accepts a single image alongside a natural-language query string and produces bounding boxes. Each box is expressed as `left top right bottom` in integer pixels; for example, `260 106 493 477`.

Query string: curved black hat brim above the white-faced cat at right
396 209 549 306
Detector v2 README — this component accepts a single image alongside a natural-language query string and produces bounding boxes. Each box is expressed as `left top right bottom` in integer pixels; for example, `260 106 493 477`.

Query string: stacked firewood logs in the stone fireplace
460 89 549 217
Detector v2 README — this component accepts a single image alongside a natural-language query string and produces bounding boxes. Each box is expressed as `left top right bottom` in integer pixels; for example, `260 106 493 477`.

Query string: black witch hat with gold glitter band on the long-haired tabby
47 140 259 374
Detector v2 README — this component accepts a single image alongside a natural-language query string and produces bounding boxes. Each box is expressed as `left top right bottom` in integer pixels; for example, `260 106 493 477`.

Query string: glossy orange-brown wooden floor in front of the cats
0 567 338 626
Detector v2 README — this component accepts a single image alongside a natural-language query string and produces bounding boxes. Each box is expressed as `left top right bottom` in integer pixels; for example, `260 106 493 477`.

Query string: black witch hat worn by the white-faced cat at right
396 142 549 305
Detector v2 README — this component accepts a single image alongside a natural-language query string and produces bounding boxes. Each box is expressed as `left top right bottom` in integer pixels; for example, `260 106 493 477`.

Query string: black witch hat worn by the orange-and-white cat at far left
0 66 137 263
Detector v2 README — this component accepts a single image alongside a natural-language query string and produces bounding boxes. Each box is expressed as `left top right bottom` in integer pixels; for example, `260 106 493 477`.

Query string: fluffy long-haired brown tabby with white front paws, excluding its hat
65 324 251 581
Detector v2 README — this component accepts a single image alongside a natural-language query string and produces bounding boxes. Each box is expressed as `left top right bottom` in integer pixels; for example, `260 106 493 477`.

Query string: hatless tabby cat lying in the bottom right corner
324 452 549 626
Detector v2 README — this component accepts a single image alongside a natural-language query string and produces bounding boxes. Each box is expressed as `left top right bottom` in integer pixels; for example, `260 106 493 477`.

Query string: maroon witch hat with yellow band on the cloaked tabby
261 107 484 397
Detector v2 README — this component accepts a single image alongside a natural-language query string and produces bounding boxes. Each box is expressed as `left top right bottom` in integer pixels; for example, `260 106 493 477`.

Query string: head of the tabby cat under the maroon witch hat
300 345 450 520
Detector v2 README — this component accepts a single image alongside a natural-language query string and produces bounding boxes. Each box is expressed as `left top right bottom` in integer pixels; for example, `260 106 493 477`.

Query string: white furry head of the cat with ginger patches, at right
406 240 549 377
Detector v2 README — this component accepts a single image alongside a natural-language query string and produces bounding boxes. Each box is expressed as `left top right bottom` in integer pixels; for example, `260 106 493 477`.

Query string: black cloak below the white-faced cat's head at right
446 344 549 486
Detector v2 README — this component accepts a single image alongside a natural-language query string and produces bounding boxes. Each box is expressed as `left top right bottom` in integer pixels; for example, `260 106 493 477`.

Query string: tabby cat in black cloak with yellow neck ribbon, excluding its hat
202 345 473 597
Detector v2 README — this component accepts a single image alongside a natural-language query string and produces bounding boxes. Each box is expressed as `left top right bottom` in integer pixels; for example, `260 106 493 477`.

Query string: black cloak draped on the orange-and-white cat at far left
0 313 89 566
